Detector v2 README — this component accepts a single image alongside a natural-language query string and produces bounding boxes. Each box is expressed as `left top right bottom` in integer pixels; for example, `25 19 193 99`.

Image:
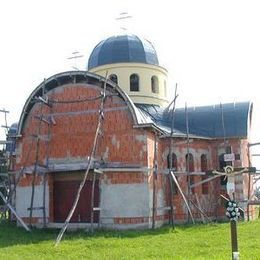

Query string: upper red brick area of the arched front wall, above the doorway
16 84 150 169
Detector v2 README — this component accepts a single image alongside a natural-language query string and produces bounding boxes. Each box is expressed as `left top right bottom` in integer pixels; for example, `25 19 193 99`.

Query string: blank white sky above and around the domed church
0 0 260 164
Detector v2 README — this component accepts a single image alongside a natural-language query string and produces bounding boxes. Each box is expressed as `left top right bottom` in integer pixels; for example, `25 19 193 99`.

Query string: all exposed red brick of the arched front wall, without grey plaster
16 84 153 225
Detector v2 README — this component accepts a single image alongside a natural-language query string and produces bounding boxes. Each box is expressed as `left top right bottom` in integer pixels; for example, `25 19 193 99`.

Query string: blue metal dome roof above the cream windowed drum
88 35 159 69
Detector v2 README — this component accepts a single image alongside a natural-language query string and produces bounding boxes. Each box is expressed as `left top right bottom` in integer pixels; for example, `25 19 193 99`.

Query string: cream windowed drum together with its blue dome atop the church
88 34 168 106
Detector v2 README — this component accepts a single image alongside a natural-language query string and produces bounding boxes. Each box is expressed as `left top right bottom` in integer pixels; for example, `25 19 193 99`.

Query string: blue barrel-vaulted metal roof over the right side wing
136 102 253 138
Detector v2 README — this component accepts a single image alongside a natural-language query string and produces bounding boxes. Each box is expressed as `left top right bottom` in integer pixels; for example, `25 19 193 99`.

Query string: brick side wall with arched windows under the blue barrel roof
153 138 251 221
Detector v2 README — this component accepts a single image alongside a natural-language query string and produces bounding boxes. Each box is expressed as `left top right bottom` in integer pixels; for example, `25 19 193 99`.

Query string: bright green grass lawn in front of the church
0 220 260 259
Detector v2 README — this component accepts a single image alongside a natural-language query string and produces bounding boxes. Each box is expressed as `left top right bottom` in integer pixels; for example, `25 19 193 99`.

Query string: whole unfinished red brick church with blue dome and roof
15 35 253 229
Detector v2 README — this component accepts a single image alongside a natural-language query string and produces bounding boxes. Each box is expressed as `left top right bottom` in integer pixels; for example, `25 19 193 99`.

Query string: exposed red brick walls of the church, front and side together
16 76 252 225
